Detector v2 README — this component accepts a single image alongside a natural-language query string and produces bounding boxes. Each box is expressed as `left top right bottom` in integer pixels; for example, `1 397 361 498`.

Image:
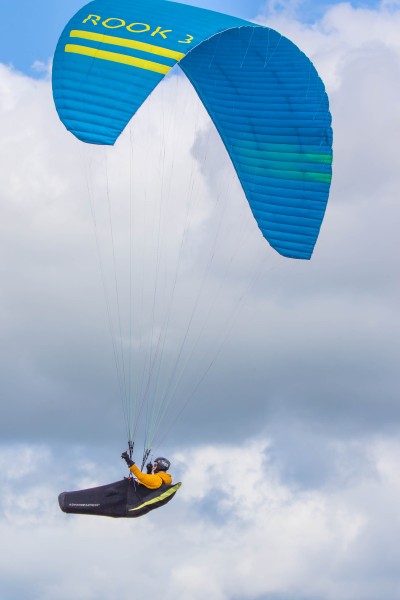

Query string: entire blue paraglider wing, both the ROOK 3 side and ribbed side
53 0 332 259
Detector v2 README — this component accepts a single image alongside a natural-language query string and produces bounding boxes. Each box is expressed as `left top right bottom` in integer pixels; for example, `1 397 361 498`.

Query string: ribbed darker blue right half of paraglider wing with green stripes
180 27 332 259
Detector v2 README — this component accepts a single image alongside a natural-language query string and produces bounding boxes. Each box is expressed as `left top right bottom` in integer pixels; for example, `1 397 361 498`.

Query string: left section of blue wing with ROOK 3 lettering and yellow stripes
53 0 247 145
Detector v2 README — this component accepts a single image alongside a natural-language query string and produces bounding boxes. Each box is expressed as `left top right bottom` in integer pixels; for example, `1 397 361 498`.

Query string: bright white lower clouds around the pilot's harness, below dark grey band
0 438 400 600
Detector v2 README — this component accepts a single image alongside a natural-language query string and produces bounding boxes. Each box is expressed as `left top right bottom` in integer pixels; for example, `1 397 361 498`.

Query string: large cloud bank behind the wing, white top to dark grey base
0 4 400 458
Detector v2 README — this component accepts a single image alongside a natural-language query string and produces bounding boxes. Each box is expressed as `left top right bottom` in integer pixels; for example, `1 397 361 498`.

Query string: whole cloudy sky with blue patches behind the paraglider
0 0 400 600
